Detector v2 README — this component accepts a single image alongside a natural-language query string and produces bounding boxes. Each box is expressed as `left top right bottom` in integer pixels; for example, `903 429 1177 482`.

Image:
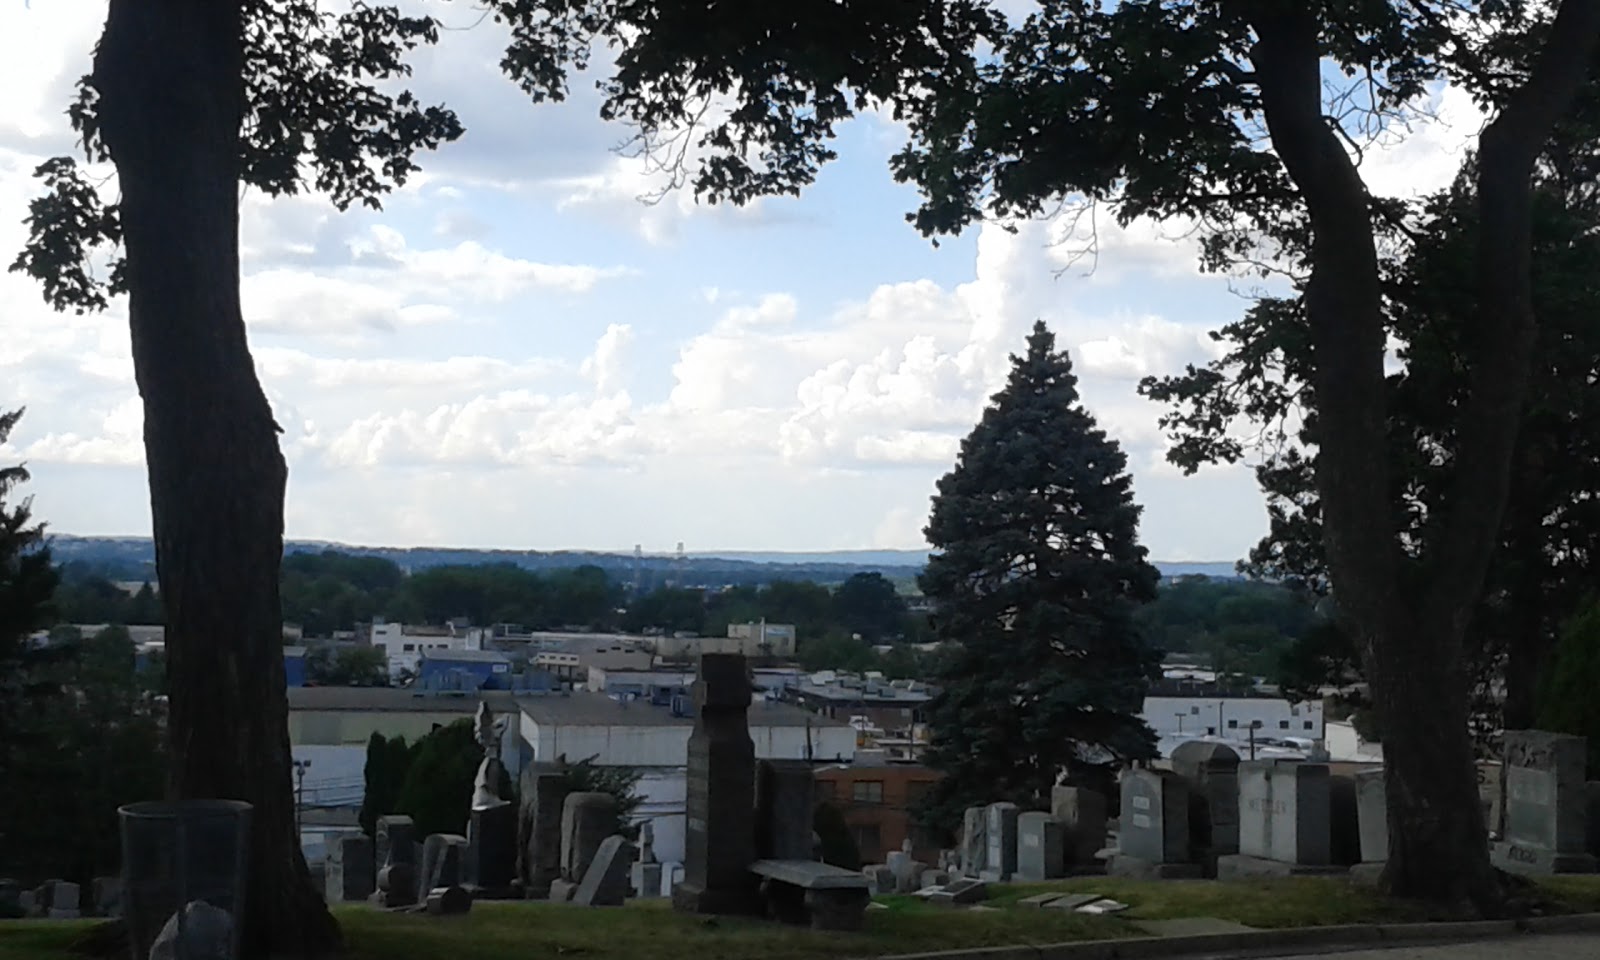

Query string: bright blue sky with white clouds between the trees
0 0 1480 562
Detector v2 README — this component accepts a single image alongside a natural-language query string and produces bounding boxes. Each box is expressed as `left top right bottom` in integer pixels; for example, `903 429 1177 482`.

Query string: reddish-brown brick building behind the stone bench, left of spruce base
816 763 944 866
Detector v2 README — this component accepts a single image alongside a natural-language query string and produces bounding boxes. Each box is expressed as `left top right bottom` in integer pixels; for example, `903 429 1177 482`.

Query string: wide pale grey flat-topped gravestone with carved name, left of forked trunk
1218 760 1341 878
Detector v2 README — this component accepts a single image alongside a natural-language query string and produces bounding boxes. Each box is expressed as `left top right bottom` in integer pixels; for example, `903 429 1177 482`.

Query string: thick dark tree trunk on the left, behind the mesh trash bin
94 0 339 957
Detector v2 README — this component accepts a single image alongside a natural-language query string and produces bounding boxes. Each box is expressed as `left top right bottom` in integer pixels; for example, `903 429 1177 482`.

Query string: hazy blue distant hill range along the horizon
50 534 1235 589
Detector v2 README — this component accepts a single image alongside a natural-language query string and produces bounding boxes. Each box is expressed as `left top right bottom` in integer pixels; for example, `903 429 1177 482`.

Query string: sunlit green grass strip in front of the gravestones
9 877 1600 960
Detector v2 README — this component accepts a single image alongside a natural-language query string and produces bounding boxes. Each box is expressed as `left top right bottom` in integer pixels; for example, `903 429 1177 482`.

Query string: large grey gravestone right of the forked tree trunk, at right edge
1491 730 1595 874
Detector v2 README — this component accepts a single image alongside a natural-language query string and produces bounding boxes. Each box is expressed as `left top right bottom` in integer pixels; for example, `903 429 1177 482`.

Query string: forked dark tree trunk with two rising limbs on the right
1246 0 1600 910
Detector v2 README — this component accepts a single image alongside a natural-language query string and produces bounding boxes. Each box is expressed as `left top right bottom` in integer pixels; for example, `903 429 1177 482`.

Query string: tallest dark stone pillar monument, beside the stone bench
672 653 765 915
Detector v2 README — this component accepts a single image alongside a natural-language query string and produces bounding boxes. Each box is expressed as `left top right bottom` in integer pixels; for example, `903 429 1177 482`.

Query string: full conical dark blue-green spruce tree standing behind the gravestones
922 322 1160 830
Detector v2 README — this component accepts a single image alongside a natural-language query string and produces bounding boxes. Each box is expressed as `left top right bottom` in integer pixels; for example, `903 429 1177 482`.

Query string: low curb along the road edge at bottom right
880 914 1600 960
